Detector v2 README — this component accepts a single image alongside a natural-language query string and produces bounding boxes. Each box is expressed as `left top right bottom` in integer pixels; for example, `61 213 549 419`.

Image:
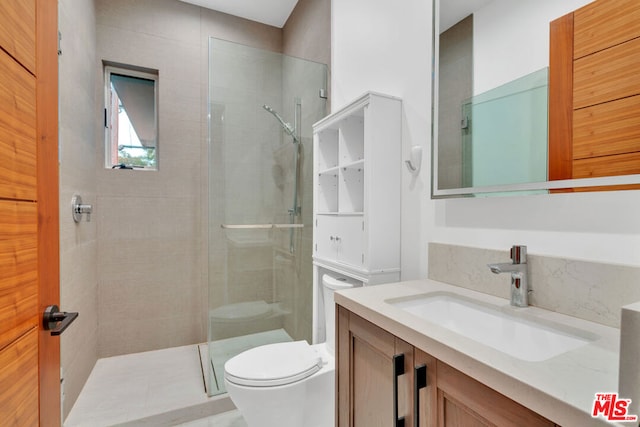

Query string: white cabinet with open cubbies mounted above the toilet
313 93 402 284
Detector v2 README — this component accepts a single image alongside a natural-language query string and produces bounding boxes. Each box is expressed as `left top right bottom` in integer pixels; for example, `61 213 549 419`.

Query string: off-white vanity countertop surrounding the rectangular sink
335 280 624 427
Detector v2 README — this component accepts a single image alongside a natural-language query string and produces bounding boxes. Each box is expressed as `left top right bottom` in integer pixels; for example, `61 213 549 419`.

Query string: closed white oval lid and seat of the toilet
224 341 322 387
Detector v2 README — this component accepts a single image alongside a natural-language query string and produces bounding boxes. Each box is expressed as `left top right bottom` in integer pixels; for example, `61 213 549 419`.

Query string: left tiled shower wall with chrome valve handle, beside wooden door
58 0 101 414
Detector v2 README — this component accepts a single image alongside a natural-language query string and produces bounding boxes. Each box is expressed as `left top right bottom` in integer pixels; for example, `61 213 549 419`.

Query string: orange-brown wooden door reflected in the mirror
549 0 640 191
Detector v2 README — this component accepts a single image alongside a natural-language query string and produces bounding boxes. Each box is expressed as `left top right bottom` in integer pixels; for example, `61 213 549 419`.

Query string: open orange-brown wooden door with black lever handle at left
0 0 60 426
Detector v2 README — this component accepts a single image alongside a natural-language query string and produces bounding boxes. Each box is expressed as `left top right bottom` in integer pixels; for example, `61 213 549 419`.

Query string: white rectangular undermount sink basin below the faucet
387 292 597 362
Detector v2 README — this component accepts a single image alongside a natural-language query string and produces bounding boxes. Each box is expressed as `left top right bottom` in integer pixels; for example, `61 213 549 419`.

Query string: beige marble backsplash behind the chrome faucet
429 242 640 328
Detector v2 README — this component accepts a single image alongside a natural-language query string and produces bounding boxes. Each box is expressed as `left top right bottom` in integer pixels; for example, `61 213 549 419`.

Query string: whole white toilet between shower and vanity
224 274 355 427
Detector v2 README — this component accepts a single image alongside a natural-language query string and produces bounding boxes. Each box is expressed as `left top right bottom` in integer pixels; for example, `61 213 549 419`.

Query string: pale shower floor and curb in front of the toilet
64 329 291 427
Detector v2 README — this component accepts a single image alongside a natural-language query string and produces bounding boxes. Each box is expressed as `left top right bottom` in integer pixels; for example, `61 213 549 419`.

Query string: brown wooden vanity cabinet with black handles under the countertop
336 305 555 427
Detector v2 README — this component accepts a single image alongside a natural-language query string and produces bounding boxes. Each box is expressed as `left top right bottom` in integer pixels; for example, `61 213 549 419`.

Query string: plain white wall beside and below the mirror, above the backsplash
332 0 640 280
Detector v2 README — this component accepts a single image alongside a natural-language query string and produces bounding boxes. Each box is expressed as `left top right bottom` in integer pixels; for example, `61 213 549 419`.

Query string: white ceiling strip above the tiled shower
180 0 298 28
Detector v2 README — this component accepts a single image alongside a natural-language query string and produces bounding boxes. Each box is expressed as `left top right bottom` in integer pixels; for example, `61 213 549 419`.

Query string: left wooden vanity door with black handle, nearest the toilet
336 306 413 427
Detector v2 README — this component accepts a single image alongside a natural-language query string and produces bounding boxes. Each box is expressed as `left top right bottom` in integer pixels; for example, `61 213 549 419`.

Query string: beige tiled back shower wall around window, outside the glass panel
95 0 330 357
